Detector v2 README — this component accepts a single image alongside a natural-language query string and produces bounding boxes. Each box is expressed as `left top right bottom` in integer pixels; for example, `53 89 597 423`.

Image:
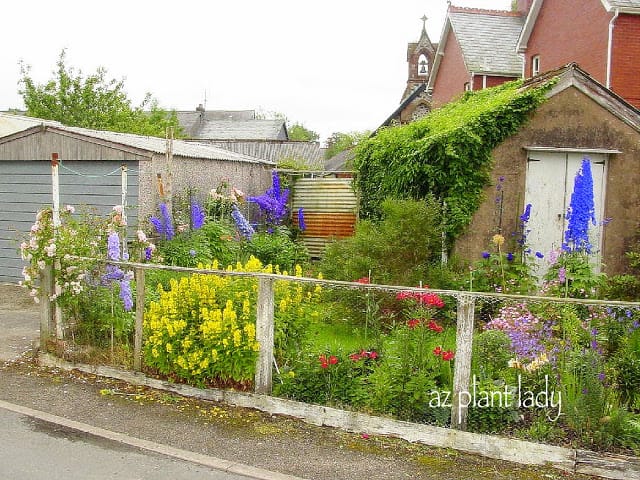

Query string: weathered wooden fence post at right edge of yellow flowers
255 277 274 394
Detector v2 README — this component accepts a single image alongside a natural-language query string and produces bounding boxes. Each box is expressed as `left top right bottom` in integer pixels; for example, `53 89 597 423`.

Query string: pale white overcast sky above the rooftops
0 0 511 140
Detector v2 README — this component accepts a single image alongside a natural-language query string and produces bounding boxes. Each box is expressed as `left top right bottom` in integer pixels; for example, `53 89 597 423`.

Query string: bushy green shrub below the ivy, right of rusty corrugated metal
320 196 442 285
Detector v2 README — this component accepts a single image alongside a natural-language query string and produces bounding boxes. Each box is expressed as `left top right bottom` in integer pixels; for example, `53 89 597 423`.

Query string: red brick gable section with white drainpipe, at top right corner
516 0 640 107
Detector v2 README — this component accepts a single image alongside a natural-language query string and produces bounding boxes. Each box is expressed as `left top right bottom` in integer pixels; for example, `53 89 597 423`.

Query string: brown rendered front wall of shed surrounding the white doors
455 87 640 274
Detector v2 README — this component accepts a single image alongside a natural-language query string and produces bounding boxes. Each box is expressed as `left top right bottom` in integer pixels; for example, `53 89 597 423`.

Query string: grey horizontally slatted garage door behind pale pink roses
0 160 138 283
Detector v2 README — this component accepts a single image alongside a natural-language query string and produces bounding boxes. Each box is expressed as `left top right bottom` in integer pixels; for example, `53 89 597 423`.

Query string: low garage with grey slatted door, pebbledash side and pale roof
0 119 275 282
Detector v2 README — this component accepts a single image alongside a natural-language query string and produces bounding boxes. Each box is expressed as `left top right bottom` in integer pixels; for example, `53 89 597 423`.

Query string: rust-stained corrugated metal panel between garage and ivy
292 177 358 258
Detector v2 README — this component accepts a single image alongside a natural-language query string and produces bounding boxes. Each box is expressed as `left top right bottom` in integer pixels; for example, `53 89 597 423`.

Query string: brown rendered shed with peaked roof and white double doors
455 64 640 274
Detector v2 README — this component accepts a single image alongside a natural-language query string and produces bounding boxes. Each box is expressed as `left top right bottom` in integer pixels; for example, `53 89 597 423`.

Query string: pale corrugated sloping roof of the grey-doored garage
52 126 273 164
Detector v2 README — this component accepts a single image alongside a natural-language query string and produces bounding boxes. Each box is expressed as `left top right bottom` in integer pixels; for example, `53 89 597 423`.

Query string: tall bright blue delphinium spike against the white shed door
562 158 596 253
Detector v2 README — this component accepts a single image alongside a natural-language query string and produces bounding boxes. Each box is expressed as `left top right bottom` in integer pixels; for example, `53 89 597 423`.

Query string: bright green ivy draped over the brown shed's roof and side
354 81 550 240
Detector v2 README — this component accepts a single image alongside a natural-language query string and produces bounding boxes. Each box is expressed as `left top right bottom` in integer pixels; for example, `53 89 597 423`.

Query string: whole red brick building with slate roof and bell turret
382 0 640 126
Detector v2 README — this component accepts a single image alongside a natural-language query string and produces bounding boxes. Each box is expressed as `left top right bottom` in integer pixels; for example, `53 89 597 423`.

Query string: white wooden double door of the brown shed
525 151 606 275
